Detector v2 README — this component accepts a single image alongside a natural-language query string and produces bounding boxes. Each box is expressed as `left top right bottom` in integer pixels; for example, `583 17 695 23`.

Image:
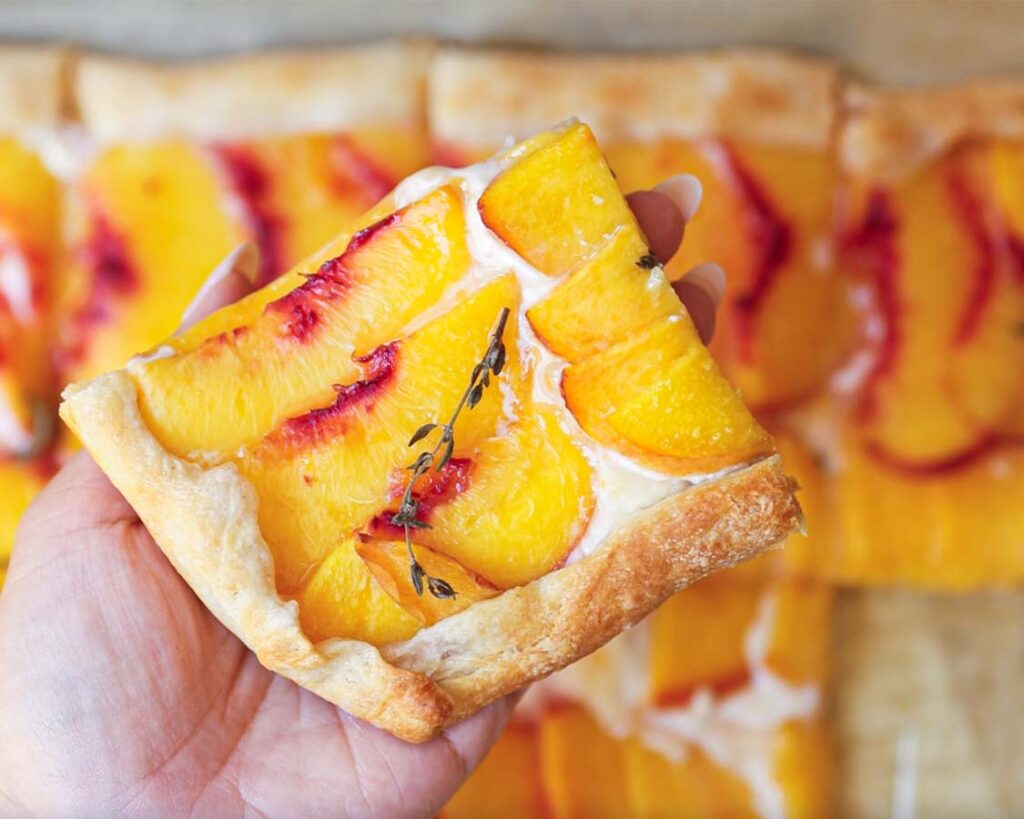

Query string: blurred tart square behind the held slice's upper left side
59 43 429 383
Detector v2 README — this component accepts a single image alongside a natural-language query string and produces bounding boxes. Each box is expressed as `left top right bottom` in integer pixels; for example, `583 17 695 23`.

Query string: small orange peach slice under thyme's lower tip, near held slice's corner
355 540 499 626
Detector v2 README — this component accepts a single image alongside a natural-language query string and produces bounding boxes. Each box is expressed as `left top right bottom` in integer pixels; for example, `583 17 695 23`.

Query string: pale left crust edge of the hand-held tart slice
60 371 453 741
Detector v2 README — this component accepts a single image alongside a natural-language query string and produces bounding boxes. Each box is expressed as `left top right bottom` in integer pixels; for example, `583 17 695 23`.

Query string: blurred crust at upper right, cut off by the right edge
839 80 1024 183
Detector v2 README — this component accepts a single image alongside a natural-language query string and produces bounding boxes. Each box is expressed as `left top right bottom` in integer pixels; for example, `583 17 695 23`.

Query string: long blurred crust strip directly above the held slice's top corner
430 49 840 150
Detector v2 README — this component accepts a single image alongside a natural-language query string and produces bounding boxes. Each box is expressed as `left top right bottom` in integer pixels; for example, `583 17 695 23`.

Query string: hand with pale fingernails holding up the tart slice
0 177 724 817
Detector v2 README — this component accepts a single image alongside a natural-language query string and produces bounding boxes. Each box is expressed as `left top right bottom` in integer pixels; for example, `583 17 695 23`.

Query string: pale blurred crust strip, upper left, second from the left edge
75 41 432 142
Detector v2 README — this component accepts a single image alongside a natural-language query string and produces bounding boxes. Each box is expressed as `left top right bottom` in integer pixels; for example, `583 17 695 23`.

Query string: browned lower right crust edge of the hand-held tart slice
382 456 802 720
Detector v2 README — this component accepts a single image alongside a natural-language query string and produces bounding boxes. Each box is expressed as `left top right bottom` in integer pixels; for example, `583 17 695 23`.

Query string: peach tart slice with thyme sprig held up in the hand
61 123 801 741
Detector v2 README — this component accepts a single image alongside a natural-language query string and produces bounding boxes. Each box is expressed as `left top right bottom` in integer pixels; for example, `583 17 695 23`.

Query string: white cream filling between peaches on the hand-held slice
392 121 742 563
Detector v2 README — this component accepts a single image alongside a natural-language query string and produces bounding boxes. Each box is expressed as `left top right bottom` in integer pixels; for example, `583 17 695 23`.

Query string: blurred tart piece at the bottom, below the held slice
441 571 831 819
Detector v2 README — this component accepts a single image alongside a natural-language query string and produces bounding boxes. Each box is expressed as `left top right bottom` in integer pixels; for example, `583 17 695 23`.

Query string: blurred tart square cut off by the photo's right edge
829 82 1024 589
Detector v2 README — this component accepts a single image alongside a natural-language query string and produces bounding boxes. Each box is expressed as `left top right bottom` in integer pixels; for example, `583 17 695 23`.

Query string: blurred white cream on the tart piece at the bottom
516 590 820 819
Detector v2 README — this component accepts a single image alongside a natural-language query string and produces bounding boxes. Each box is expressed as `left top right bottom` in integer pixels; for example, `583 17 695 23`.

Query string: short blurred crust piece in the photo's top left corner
0 46 69 134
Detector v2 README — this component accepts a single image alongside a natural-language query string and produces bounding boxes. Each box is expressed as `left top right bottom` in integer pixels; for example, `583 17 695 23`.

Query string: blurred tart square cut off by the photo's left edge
0 47 66 580
